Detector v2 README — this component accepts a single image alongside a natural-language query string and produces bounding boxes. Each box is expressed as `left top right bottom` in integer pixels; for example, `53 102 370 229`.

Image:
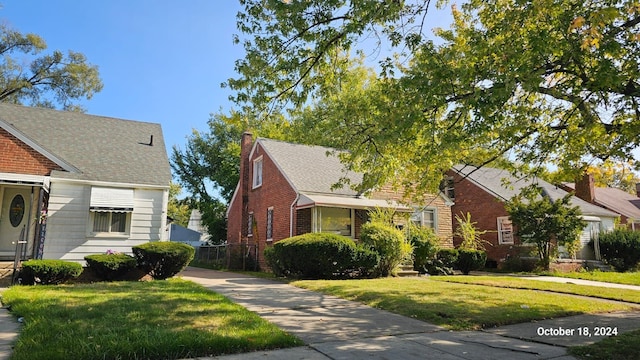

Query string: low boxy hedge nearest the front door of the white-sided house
20 260 82 285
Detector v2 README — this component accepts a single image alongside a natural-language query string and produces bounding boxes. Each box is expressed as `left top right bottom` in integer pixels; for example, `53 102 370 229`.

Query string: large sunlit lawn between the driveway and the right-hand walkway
291 278 633 330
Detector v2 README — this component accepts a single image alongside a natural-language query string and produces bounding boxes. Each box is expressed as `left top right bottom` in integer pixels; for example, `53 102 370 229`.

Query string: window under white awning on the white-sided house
89 186 133 236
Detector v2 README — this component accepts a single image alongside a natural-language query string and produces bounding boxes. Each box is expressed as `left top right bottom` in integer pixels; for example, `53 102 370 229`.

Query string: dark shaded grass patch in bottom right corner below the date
567 330 640 360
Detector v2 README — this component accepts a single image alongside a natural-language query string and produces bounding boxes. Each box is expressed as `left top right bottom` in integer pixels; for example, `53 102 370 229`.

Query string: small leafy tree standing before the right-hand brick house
505 185 586 270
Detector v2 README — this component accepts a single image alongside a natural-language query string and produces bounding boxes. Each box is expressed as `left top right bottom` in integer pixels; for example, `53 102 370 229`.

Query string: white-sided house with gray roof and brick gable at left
0 104 171 262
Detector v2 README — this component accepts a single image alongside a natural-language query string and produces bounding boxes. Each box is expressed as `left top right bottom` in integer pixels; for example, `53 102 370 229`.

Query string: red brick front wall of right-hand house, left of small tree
448 171 520 263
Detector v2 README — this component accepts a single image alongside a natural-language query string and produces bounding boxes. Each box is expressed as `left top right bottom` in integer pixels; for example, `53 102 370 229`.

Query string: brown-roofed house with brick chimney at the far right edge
560 174 640 231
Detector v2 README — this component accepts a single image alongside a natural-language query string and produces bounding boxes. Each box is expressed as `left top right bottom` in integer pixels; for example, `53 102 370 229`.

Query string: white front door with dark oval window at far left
0 187 33 257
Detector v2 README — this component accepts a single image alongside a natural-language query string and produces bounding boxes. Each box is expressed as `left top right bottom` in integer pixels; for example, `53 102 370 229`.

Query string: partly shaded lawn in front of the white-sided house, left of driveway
2 279 303 360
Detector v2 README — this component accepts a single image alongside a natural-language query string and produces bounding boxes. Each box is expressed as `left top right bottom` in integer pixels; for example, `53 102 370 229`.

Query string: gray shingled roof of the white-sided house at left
0 103 171 186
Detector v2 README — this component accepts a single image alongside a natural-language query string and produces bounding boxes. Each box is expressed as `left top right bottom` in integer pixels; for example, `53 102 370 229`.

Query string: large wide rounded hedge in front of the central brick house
264 233 379 279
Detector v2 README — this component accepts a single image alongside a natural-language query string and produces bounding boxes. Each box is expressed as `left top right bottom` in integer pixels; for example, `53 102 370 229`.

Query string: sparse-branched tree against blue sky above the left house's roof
0 25 102 111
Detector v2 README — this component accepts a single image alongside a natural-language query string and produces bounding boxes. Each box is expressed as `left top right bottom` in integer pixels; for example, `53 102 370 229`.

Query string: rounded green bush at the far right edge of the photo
598 229 640 271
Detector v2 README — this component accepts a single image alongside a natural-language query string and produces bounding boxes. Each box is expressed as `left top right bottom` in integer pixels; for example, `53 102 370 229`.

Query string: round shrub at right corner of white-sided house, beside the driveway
132 241 196 280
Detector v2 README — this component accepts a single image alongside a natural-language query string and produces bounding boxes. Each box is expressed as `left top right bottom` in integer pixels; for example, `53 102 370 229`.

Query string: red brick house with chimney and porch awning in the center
227 133 452 265
